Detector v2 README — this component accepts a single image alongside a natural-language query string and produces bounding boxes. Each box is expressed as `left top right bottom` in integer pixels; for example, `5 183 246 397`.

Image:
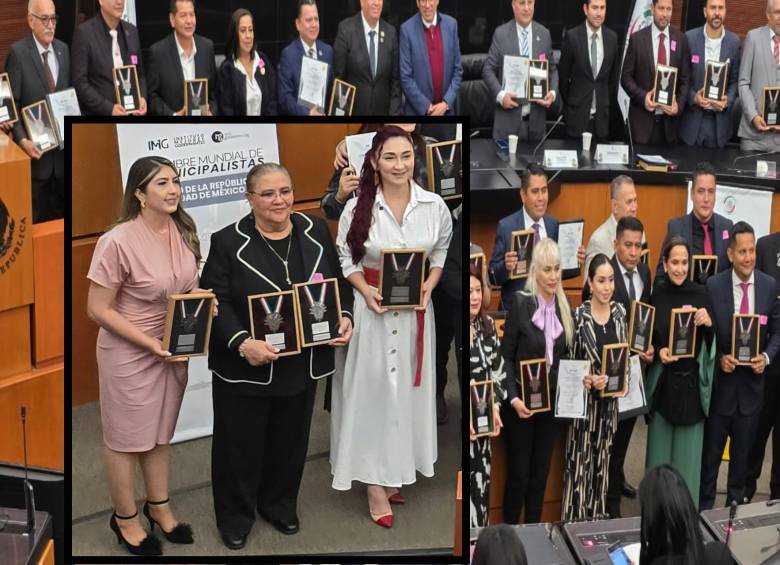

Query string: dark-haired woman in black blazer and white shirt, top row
217 8 277 116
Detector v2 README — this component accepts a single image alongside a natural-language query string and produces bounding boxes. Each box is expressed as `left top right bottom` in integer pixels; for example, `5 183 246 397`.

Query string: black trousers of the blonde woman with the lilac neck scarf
501 402 559 524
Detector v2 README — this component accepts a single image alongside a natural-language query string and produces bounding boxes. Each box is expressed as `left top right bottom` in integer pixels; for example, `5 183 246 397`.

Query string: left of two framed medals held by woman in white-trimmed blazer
247 290 301 357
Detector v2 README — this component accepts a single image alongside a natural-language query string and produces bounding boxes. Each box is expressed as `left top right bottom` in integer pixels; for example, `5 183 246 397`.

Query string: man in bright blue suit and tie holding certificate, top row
279 0 333 116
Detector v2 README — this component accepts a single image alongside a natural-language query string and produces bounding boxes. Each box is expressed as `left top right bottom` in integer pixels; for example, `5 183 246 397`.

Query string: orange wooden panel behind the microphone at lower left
0 363 65 471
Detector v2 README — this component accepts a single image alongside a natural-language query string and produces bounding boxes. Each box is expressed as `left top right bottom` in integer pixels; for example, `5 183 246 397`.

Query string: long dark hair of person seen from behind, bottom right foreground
639 464 704 565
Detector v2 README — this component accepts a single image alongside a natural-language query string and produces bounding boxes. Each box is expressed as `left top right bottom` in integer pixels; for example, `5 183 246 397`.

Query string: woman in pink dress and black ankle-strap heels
87 157 200 555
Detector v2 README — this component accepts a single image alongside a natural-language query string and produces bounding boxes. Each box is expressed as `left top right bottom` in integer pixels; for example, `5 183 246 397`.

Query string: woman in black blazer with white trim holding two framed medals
201 163 352 549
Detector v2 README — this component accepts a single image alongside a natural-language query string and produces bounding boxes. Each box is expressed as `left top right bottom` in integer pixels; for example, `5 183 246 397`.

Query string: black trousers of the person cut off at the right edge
745 365 780 499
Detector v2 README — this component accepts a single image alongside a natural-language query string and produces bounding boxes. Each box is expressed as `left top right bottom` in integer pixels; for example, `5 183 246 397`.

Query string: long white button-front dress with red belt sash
330 183 452 490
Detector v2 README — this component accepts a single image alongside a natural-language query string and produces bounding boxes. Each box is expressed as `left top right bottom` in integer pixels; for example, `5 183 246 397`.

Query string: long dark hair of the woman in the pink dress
108 156 200 263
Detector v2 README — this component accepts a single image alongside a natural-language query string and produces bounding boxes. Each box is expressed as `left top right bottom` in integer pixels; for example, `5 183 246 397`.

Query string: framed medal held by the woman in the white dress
379 248 425 310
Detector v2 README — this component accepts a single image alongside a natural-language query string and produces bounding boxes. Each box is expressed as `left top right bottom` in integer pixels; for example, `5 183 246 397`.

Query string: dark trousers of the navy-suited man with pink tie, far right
699 400 761 511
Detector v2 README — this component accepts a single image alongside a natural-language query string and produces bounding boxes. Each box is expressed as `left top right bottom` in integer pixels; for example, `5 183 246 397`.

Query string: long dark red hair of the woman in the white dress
347 126 414 265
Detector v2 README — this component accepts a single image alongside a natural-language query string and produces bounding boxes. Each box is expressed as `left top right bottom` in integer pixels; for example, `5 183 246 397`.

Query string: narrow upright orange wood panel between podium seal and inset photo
33 220 65 365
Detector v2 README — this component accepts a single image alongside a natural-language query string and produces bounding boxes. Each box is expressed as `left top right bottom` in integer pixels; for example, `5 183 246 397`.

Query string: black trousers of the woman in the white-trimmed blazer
211 377 317 536
